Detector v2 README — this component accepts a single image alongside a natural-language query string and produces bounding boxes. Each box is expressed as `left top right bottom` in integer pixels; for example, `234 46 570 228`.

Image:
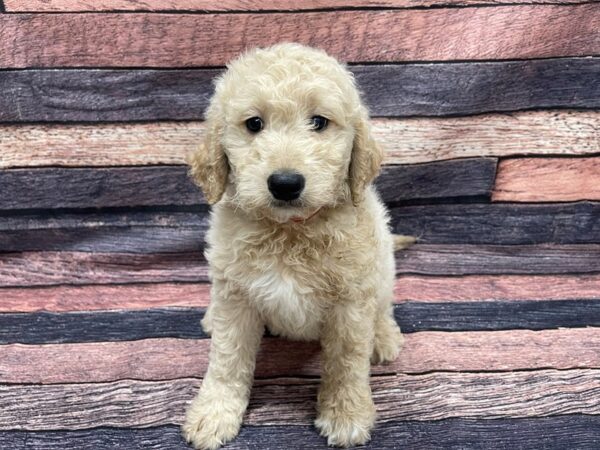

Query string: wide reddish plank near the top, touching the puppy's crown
0 4 600 68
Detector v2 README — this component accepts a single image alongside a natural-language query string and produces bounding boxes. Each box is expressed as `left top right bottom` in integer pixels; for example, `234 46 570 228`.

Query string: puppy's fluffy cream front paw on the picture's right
315 404 375 447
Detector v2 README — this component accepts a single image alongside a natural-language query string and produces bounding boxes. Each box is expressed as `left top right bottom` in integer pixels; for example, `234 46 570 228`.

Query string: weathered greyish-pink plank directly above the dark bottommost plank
0 369 600 430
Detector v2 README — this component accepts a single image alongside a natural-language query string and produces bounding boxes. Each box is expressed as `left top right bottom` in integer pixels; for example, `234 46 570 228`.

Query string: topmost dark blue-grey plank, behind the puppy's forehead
0 60 600 122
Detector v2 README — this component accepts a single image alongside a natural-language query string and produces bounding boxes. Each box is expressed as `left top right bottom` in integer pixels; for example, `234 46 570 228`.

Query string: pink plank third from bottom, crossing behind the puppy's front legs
0 328 600 384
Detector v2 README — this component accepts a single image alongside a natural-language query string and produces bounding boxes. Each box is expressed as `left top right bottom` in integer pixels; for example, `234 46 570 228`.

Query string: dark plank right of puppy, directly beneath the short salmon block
390 202 600 245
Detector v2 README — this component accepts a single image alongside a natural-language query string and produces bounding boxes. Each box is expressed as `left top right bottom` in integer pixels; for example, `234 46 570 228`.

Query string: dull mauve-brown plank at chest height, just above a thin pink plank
0 244 600 287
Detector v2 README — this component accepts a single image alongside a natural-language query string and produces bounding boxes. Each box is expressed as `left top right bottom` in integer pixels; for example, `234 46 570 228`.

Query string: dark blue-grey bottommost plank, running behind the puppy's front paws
0 414 600 450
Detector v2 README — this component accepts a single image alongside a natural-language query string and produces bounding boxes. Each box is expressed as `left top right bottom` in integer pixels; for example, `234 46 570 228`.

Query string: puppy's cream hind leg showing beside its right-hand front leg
371 302 404 364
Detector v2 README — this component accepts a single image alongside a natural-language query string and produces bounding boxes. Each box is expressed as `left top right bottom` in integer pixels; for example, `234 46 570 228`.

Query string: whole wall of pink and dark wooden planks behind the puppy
0 0 600 449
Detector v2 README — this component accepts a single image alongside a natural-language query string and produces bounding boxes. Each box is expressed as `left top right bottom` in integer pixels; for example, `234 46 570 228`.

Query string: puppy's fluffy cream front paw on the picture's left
181 400 243 450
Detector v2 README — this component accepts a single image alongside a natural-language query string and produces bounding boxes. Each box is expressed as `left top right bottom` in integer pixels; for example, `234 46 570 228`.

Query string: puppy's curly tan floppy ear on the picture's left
187 111 229 205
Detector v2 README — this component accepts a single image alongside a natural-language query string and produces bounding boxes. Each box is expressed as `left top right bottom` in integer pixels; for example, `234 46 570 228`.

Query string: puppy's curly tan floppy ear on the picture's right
349 108 383 206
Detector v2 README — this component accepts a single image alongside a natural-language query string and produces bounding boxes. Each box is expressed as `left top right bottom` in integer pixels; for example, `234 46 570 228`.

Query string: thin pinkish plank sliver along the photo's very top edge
4 0 589 12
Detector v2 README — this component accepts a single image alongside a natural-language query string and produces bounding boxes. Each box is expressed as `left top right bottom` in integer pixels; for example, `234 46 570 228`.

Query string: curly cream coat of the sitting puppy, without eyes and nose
183 44 409 449
